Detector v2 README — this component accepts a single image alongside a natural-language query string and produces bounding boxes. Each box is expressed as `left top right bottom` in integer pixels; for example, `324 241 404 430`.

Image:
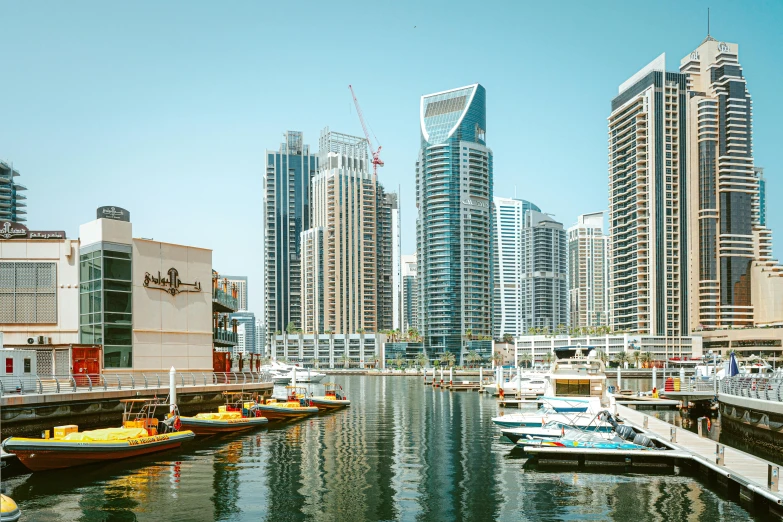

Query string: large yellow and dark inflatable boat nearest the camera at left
2 399 195 471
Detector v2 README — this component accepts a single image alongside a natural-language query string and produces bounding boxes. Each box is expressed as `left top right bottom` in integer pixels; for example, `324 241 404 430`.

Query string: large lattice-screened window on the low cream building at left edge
0 262 57 324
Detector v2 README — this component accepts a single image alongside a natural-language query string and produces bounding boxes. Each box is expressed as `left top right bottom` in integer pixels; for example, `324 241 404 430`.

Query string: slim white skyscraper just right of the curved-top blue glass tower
492 196 541 339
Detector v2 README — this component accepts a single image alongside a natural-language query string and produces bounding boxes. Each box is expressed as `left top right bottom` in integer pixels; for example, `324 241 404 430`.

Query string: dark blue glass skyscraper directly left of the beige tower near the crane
264 131 318 335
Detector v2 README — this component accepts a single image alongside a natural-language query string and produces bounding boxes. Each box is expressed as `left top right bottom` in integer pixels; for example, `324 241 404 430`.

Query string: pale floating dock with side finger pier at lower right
526 401 783 519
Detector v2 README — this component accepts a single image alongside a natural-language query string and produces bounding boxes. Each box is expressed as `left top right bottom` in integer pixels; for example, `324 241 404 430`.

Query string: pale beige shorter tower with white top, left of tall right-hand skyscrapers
568 212 609 327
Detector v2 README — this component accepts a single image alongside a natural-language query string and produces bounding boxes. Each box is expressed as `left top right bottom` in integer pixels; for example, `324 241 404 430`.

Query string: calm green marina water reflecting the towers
6 376 749 522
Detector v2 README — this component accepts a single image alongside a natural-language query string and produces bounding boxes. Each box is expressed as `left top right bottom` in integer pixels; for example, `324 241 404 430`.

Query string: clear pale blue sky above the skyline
0 1 783 314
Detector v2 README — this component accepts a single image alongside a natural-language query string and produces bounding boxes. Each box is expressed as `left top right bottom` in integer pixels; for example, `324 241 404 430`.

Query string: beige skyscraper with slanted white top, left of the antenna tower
608 54 689 336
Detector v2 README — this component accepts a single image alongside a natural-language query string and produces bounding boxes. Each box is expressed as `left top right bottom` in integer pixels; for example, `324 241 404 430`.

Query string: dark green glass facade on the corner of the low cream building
79 243 133 368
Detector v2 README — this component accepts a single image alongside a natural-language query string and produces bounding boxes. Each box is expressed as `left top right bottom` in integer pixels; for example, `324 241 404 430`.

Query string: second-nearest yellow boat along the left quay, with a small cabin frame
179 392 269 435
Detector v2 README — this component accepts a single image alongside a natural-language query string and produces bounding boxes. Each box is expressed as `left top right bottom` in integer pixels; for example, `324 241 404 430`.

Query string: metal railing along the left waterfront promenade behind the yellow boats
0 371 272 395
